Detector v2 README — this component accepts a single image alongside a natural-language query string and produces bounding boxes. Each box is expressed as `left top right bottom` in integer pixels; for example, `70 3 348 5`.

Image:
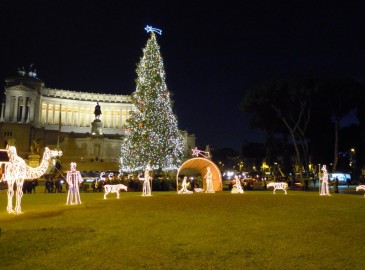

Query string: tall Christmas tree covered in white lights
120 29 184 172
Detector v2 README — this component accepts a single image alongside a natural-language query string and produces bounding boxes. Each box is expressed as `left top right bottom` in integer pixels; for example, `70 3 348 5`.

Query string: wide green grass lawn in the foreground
0 190 365 270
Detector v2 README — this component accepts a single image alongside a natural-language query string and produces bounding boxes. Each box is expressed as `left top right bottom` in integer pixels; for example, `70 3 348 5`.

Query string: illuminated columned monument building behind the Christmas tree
0 71 195 171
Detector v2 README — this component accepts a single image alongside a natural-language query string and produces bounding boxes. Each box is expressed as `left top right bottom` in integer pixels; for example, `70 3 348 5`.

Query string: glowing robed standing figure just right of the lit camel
66 162 84 204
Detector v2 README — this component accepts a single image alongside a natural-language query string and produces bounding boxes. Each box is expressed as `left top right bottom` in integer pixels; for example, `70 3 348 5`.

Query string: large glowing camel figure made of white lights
3 146 62 214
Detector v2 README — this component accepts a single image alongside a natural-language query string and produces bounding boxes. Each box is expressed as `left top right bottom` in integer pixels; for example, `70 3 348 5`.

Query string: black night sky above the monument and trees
0 0 365 150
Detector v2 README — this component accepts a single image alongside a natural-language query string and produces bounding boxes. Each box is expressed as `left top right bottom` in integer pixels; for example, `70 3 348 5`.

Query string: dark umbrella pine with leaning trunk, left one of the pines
241 78 318 180
